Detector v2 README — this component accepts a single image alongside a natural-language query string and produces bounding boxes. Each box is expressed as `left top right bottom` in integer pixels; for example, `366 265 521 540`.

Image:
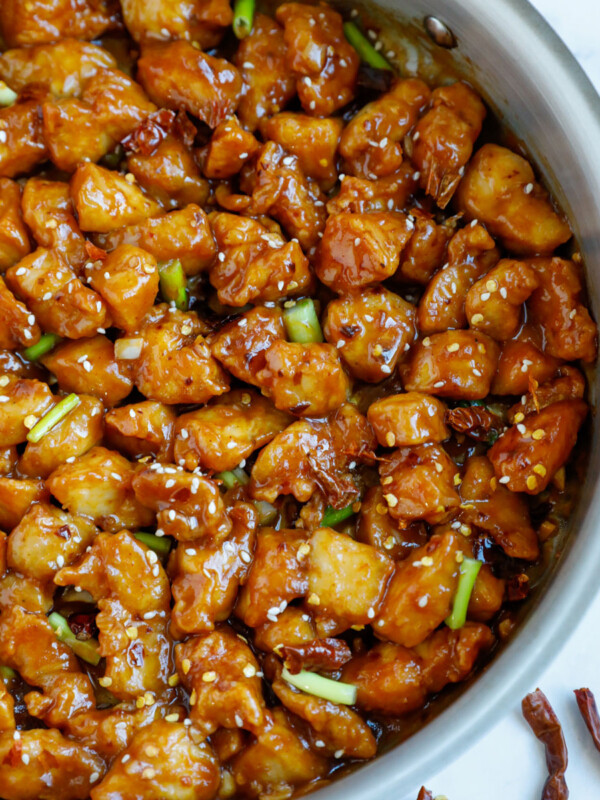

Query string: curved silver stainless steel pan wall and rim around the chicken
316 0 600 800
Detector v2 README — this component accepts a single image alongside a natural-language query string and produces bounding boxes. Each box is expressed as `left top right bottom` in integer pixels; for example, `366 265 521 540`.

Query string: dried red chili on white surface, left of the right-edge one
521 689 569 800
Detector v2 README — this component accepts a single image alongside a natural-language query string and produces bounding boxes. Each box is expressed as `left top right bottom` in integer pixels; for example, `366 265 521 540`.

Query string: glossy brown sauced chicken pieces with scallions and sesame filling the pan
0 0 597 800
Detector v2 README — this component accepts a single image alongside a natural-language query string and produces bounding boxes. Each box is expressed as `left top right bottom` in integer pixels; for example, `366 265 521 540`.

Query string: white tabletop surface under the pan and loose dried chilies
398 0 600 800
